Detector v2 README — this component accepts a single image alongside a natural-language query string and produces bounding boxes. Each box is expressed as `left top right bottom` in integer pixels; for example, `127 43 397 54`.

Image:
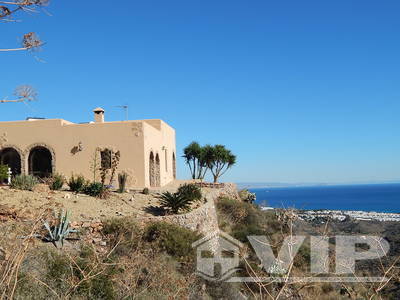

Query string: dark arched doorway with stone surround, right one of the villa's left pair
28 146 53 178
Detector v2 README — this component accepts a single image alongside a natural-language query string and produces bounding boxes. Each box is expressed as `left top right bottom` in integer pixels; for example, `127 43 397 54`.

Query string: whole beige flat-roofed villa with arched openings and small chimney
0 108 176 187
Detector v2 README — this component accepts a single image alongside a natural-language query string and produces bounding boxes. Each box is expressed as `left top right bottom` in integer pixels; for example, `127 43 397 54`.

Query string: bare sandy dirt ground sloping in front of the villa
0 181 200 222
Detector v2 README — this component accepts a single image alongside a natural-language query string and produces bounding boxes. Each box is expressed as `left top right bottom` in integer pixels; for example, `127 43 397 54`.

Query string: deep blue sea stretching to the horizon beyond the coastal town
249 183 400 213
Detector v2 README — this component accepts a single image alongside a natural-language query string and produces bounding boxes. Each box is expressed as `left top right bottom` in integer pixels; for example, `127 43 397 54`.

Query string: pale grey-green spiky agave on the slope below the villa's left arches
43 210 77 247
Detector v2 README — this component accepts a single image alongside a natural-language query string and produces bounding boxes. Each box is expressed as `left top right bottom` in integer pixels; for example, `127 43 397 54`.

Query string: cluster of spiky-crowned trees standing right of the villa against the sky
183 142 236 183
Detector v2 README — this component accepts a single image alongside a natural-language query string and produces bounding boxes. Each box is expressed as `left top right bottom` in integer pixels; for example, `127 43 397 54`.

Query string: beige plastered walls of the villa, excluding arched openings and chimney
0 115 175 188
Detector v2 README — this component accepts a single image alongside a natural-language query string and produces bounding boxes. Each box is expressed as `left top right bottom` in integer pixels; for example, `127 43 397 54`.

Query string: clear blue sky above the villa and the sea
0 0 400 183
